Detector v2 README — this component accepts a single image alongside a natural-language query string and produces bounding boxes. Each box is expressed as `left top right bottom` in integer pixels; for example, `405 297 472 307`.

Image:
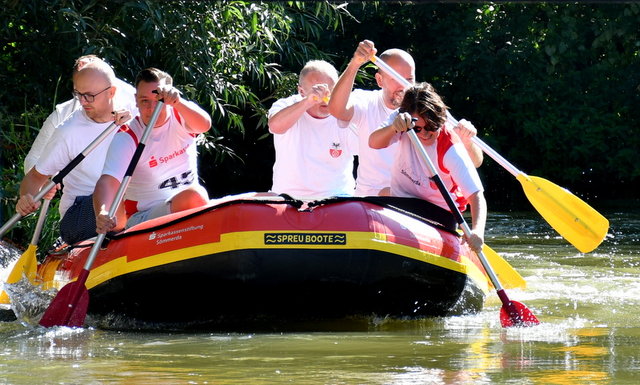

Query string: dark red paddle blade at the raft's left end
40 281 89 328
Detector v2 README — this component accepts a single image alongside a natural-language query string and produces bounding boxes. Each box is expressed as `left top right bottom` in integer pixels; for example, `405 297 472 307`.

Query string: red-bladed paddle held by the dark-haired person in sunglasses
407 130 540 327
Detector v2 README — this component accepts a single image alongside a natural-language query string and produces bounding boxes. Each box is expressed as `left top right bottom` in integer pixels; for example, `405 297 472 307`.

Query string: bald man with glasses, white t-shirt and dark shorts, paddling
16 58 131 244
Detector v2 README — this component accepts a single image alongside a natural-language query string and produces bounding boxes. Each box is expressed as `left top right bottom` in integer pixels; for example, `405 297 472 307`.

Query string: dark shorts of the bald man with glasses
60 195 97 245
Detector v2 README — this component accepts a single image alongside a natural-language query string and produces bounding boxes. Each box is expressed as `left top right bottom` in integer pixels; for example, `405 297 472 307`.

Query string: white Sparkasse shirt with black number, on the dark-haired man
102 107 199 211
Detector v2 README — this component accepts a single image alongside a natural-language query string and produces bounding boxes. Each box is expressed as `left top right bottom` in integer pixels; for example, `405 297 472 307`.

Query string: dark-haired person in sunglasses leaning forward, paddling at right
369 82 487 251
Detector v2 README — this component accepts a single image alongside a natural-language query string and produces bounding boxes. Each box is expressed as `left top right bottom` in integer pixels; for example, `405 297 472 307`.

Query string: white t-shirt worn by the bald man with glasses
35 109 115 217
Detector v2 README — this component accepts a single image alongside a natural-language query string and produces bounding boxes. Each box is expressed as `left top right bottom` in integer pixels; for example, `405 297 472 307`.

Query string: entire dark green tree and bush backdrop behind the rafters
0 0 640 244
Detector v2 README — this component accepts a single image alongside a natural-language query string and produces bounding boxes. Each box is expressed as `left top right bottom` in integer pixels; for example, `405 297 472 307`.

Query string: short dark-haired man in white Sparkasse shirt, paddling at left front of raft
93 68 211 233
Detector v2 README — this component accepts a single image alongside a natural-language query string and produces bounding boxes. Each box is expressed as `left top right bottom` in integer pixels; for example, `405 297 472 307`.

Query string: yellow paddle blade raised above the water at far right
516 173 609 253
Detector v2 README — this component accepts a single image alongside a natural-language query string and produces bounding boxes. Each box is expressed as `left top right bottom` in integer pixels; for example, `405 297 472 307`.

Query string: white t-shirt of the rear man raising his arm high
349 89 398 196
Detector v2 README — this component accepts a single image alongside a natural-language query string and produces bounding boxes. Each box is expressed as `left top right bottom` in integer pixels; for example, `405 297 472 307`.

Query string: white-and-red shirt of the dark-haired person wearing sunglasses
386 113 484 210
